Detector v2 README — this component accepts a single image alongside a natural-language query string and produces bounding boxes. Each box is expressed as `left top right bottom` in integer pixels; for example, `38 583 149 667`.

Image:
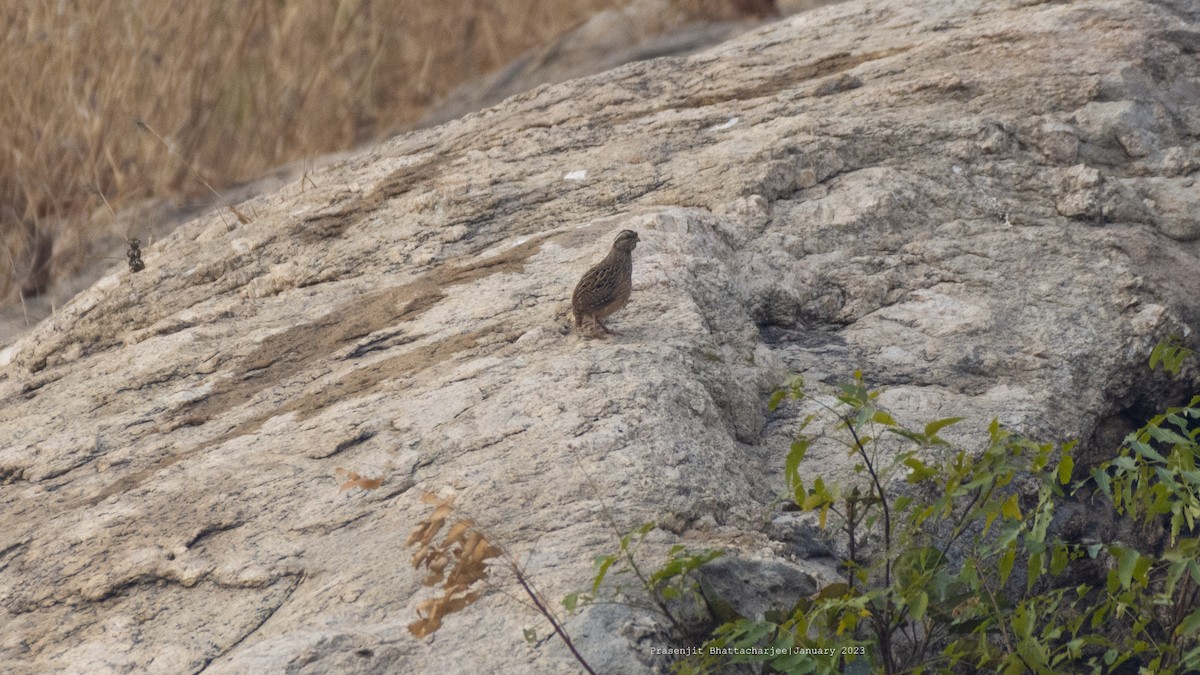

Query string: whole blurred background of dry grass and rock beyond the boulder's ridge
0 0 829 336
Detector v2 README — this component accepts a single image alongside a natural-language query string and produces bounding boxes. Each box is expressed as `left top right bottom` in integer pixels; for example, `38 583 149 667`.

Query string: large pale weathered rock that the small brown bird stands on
0 0 1200 673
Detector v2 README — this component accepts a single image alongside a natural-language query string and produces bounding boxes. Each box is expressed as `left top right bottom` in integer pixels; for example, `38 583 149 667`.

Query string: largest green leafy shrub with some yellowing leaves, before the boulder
677 369 1200 673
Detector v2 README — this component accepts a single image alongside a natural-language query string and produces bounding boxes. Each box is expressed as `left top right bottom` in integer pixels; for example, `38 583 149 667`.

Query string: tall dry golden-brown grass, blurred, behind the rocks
0 0 625 303
